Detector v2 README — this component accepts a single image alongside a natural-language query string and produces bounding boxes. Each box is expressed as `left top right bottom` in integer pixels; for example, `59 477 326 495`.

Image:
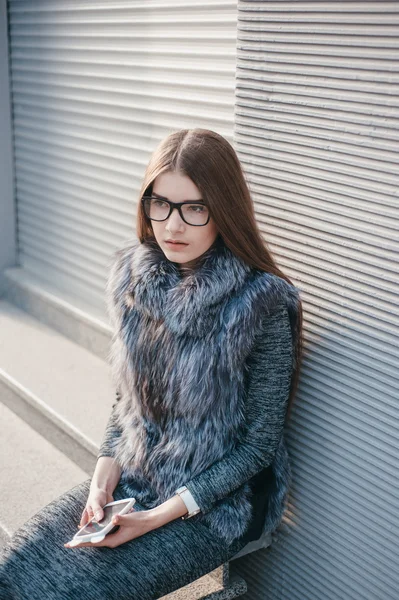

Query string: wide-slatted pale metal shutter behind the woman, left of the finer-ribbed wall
9 0 237 312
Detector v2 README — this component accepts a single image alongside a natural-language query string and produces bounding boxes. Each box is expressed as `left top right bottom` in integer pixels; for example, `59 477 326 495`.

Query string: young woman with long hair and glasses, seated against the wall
0 129 302 600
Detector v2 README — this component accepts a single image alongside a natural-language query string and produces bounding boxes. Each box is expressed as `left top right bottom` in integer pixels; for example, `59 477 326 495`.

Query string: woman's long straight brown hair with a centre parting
136 128 303 420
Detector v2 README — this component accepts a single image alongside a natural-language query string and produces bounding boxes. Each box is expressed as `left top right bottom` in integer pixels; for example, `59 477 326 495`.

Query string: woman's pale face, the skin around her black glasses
151 171 218 267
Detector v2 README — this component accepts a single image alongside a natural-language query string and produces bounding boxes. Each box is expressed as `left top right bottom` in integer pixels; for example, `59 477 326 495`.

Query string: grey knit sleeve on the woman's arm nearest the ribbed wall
184 304 294 513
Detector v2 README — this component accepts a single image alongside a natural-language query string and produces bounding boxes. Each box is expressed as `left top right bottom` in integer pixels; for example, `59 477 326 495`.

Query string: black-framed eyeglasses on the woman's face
141 196 211 227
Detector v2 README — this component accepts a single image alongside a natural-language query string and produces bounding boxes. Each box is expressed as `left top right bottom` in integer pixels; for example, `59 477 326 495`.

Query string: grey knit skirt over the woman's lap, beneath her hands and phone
0 479 250 600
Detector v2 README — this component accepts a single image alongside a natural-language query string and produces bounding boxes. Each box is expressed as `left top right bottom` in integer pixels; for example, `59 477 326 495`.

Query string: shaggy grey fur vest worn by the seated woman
106 237 300 543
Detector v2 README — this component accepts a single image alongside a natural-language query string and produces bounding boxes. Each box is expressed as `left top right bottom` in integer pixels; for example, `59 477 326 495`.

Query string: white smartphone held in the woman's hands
68 498 136 546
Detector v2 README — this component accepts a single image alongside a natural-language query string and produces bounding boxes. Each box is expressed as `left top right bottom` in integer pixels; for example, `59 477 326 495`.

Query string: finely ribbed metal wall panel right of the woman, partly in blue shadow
233 1 399 600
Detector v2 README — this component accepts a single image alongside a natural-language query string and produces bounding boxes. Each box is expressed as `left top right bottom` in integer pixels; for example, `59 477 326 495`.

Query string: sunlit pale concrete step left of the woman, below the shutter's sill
0 300 115 470
